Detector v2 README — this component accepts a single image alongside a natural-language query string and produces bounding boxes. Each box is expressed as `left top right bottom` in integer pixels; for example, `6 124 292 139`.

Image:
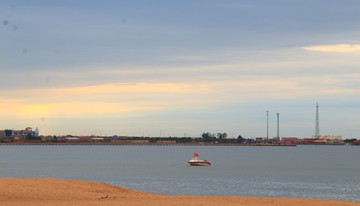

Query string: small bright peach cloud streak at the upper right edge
303 44 360 53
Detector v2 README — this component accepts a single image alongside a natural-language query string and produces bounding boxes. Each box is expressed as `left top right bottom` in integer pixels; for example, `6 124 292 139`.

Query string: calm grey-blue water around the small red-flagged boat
0 145 360 202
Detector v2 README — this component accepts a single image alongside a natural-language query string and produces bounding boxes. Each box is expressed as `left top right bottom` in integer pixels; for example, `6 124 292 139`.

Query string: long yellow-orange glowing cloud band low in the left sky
0 83 214 118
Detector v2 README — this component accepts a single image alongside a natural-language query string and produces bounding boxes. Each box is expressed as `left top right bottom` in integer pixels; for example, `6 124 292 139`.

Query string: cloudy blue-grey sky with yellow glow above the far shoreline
0 0 360 139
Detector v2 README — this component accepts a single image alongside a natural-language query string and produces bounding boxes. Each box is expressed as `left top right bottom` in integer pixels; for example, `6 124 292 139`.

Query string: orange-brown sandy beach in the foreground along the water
0 178 360 206
